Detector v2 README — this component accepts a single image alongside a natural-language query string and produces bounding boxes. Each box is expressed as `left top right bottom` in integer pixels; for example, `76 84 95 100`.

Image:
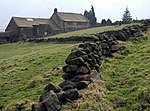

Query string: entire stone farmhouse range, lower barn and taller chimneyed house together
0 8 90 40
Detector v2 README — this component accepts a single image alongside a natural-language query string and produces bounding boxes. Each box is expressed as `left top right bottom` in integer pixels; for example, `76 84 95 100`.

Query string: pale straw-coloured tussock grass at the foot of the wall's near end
62 81 113 111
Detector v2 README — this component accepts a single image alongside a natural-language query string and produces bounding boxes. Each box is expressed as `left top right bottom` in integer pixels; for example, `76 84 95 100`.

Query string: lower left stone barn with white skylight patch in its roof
6 17 61 39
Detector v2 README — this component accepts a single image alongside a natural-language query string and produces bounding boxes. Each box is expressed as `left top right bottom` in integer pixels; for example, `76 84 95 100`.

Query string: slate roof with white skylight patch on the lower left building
12 17 60 30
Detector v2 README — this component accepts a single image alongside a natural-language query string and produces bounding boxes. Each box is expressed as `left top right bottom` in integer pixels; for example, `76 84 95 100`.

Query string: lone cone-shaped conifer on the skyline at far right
122 7 132 23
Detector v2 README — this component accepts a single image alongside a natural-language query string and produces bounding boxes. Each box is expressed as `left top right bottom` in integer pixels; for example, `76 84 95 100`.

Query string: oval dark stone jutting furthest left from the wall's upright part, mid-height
63 65 78 73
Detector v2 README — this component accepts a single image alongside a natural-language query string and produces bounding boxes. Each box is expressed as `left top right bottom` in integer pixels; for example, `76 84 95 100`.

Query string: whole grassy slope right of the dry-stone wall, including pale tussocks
63 33 150 111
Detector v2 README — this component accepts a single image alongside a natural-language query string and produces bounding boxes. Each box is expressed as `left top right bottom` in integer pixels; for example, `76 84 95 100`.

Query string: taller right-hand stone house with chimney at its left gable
51 8 90 32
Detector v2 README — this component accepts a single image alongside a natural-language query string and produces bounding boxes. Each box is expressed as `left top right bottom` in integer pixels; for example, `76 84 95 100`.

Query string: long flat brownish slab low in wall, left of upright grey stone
71 74 92 82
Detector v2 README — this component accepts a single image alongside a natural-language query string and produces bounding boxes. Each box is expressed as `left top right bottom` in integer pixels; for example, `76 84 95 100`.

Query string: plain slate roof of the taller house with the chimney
56 12 90 22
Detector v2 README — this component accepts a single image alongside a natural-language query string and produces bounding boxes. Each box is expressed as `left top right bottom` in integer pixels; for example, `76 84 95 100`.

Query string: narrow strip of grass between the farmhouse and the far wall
46 23 139 38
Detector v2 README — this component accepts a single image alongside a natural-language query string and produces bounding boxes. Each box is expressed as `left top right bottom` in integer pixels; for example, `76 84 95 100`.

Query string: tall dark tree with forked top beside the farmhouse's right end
84 6 97 27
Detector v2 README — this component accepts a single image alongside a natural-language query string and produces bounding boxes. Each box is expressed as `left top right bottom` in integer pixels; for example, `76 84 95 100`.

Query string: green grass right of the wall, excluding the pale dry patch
102 34 150 111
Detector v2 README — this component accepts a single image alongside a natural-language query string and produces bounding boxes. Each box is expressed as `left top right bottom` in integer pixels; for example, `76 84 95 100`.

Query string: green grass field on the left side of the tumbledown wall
0 43 77 110
